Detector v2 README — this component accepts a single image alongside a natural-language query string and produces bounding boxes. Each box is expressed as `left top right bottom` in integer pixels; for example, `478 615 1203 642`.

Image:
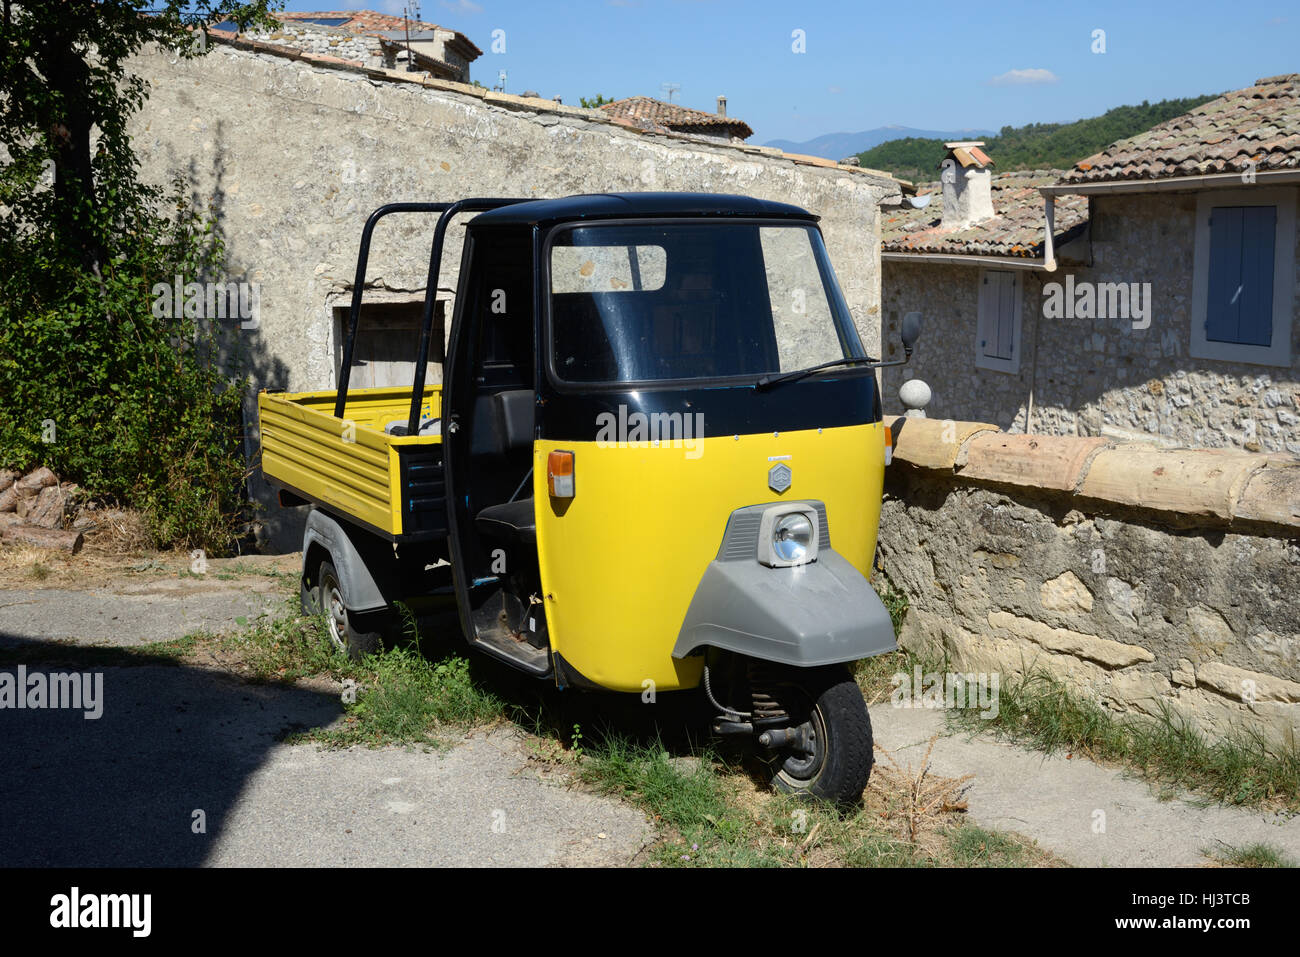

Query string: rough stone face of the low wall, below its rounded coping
880 468 1300 741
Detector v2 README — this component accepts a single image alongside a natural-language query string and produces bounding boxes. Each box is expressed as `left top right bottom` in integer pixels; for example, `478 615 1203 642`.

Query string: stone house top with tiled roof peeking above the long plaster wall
213 10 482 83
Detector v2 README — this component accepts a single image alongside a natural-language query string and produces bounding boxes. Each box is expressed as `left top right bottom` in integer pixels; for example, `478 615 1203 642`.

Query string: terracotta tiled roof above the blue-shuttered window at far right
1061 73 1300 185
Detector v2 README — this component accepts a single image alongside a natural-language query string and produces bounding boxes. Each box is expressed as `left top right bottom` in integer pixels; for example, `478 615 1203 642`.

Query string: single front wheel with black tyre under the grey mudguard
772 664 872 806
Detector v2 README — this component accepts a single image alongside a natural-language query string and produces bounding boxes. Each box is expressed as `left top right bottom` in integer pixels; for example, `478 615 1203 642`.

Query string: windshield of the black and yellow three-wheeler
550 221 863 384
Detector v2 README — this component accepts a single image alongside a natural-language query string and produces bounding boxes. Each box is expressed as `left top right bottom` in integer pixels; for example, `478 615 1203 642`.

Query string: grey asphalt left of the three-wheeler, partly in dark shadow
0 564 653 867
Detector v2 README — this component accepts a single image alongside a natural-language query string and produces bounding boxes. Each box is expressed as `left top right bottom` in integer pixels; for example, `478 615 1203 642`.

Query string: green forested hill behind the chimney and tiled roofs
858 94 1218 182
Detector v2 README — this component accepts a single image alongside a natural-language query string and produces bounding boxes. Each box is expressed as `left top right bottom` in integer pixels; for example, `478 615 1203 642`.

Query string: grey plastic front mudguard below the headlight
672 549 898 667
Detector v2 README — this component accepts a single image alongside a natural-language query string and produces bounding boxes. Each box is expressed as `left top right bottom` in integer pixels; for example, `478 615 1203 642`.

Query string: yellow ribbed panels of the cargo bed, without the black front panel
257 385 442 536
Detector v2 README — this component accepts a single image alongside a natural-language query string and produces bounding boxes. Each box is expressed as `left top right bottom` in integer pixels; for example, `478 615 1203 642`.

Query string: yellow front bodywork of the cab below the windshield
533 423 884 692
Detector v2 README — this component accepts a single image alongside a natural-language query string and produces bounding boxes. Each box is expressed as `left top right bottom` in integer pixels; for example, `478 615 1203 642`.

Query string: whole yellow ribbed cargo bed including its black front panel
257 385 447 541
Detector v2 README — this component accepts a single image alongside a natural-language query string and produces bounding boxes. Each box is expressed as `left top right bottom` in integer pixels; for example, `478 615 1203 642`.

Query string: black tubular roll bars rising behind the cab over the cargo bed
334 199 525 436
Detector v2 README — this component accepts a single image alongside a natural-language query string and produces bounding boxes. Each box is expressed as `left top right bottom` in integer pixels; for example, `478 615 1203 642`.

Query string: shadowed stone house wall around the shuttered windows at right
883 194 1300 454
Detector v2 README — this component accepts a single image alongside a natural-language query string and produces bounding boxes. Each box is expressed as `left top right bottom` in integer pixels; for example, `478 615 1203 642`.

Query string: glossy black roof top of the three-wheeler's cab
472 192 819 226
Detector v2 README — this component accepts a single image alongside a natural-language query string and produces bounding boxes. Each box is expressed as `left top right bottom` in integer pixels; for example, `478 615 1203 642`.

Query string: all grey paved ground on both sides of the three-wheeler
0 561 1300 866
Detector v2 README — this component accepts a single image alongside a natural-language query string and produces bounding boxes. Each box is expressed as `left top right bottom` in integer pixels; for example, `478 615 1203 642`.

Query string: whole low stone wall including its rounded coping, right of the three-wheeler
880 417 1300 741
